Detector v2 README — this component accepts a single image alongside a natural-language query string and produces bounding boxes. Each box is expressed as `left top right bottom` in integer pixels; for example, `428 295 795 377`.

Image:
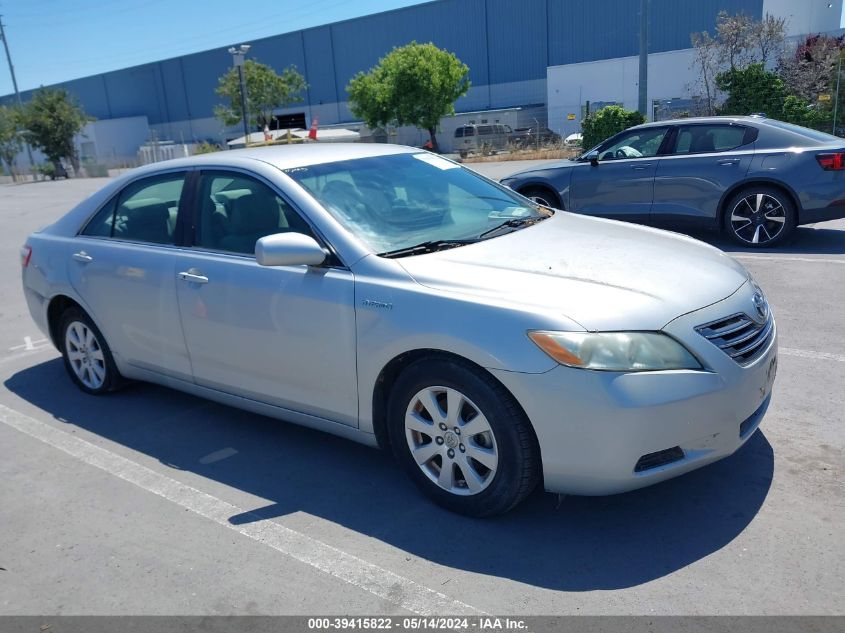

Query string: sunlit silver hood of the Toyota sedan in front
397 211 748 331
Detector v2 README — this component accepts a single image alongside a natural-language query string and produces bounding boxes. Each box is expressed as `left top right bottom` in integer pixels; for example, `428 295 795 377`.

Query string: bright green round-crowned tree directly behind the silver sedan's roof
346 42 470 151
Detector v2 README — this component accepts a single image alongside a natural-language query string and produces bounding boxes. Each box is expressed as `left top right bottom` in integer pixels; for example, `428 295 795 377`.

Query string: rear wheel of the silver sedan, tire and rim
59 307 125 395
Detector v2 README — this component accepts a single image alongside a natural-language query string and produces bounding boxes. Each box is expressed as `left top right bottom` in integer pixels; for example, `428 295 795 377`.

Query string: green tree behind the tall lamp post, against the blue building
214 59 308 128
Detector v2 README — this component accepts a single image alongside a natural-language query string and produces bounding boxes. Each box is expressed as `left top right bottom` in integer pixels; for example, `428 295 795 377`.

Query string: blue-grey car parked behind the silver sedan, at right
502 116 845 247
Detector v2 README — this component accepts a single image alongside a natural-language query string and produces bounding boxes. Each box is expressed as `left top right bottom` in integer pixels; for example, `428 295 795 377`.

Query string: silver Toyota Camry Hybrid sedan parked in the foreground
21 144 777 516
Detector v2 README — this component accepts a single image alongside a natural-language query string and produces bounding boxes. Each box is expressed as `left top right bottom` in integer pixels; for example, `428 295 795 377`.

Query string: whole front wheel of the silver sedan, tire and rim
388 359 540 517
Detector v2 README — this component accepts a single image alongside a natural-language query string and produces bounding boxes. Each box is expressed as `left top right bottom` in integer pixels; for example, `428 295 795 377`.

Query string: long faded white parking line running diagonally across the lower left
0 404 485 615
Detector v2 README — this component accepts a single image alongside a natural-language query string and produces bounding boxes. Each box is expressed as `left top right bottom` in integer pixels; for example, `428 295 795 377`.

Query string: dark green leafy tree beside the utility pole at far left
20 88 94 174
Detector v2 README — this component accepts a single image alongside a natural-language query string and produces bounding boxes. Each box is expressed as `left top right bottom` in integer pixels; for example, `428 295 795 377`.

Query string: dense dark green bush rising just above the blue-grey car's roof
716 64 787 119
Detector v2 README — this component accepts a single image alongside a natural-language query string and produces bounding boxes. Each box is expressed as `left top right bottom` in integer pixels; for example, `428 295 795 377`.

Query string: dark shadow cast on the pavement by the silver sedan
5 359 774 591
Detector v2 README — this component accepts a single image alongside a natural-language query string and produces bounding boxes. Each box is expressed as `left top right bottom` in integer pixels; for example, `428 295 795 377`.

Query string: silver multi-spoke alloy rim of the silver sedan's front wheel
405 387 499 495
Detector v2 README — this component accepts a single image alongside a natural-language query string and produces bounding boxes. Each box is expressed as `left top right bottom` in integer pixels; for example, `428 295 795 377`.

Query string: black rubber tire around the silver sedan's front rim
387 359 540 517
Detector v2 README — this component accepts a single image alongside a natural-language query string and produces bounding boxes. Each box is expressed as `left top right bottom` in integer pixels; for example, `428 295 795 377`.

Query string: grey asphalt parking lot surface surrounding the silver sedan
0 163 845 615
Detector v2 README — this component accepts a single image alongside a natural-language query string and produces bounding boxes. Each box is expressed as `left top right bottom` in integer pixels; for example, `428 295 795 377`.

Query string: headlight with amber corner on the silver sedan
528 331 701 371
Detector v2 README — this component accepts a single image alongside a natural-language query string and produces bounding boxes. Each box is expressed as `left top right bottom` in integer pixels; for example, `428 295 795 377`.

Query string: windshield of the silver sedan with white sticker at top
285 152 550 253
